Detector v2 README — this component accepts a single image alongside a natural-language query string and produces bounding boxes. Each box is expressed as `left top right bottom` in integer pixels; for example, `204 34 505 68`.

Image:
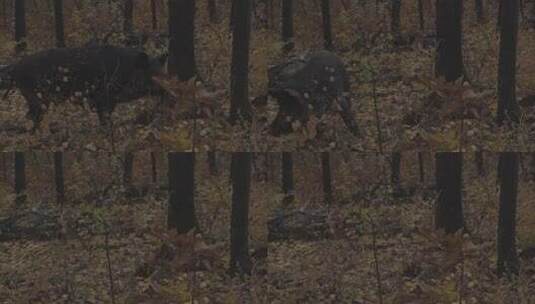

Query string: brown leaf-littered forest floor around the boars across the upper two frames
0 16 535 152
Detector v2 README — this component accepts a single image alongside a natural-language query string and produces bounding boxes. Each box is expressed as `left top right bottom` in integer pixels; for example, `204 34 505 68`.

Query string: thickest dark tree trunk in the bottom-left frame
167 152 198 234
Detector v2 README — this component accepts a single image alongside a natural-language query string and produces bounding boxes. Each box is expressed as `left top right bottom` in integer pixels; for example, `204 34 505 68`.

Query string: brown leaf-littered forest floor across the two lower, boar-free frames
0 154 535 304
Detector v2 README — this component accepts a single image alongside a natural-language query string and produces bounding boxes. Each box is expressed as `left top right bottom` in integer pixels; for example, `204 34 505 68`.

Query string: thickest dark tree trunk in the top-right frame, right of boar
435 0 463 82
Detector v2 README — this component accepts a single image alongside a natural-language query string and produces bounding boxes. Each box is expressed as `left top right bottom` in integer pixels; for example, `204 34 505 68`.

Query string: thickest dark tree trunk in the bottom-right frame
435 152 464 233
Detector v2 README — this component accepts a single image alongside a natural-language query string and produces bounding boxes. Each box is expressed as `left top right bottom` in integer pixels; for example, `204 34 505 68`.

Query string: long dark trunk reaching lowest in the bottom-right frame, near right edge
497 152 519 277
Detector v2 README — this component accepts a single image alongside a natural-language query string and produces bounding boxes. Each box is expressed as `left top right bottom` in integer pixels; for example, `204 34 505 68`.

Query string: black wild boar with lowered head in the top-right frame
268 51 359 136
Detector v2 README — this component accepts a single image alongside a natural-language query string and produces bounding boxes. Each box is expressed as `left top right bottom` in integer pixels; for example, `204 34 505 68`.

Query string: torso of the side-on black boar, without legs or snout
11 46 150 105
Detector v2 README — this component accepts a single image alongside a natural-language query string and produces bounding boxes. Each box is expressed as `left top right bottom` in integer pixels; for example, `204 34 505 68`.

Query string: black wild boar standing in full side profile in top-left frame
0 45 165 130
